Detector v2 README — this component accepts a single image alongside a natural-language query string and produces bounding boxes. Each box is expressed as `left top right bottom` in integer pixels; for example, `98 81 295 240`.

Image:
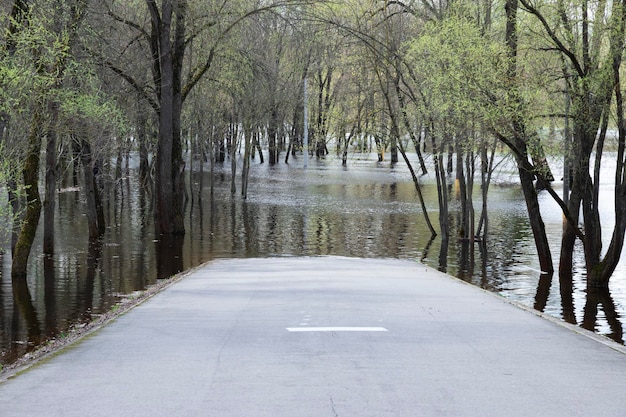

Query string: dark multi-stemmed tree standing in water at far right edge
511 0 626 287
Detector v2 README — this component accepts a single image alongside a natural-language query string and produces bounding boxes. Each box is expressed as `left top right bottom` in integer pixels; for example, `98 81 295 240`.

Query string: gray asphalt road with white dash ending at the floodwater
0 257 626 417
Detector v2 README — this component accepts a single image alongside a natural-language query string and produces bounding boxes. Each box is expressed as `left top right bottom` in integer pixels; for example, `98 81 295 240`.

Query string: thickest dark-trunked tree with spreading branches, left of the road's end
99 0 322 234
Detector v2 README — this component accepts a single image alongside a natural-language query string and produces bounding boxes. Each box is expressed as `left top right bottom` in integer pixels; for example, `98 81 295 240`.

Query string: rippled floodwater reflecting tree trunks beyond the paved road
0 154 626 364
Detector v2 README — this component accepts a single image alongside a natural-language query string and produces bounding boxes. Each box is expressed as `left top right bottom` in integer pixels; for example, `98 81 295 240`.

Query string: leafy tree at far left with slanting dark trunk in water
2 0 88 278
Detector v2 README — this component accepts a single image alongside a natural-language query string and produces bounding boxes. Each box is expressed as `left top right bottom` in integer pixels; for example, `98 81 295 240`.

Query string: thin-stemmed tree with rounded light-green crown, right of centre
397 14 504 242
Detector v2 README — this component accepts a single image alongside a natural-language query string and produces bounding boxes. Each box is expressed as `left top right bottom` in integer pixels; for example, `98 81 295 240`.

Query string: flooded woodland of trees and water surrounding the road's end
0 0 626 370
